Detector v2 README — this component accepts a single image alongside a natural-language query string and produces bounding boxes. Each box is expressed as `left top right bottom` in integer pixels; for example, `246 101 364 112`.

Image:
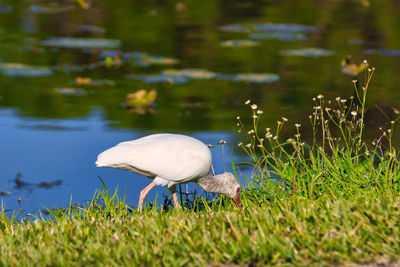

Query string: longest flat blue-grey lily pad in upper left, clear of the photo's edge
42 37 121 49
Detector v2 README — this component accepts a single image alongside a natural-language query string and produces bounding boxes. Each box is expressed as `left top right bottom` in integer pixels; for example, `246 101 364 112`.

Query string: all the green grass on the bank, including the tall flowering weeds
0 66 400 266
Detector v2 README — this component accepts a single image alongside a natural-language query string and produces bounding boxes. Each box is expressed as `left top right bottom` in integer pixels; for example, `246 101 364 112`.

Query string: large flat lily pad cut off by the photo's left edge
0 63 53 77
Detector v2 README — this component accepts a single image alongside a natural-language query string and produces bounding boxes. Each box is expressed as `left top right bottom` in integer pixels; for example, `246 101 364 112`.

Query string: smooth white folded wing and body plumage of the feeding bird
97 134 211 182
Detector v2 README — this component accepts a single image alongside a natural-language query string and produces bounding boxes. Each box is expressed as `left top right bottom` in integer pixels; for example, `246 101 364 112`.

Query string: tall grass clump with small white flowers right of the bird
238 66 400 202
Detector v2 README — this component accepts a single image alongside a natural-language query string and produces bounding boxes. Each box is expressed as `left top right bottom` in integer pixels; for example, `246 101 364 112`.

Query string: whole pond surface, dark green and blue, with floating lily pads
0 0 400 214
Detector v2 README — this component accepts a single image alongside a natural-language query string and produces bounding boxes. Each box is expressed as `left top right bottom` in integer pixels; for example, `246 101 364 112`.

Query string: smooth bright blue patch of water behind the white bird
0 109 248 212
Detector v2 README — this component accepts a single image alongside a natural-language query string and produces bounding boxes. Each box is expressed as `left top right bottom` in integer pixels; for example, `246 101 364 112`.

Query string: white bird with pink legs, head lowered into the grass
96 134 241 210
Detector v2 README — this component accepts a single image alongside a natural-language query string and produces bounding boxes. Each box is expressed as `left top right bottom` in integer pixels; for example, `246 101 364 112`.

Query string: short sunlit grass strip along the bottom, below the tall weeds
0 191 400 266
